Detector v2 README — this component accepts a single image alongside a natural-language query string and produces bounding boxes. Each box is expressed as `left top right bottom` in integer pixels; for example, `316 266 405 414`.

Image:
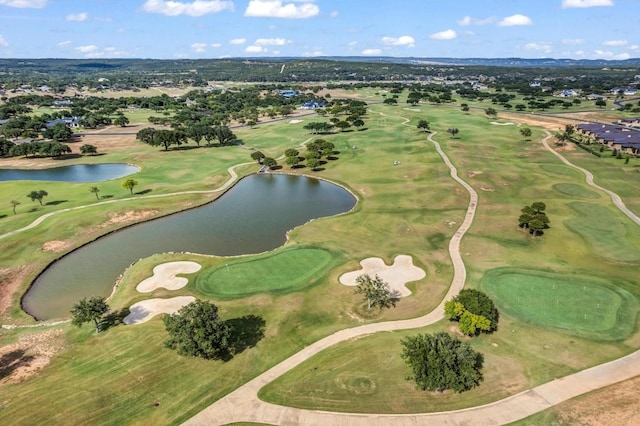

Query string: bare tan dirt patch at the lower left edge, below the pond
0 329 64 387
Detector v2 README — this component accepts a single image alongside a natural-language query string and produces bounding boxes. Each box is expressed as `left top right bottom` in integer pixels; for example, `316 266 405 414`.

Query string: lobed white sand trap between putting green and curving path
339 254 427 297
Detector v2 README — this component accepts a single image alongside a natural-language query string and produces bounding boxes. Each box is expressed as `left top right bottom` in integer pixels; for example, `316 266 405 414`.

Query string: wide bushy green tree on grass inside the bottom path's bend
401 332 484 392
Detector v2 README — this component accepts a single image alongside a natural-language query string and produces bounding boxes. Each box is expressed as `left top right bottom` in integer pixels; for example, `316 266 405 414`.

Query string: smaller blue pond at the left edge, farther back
0 164 140 183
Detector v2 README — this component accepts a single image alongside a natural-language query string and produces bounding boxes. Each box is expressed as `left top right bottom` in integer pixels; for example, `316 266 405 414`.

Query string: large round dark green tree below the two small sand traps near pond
163 300 233 359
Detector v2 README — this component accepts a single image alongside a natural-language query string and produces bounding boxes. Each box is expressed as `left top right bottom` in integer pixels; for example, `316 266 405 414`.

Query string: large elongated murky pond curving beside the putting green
22 174 356 320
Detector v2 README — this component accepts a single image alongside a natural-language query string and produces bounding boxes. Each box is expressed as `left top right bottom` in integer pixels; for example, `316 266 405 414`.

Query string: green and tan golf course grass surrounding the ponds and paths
0 88 640 424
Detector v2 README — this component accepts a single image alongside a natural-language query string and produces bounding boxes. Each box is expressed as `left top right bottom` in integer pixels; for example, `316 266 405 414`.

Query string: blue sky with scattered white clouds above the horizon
0 0 640 59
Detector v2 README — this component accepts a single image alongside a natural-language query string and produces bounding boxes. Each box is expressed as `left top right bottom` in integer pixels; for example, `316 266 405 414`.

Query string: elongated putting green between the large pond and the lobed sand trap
195 248 338 299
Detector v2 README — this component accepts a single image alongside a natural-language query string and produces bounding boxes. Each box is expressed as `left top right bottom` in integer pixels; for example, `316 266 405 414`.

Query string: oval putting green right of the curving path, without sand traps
481 268 638 340
